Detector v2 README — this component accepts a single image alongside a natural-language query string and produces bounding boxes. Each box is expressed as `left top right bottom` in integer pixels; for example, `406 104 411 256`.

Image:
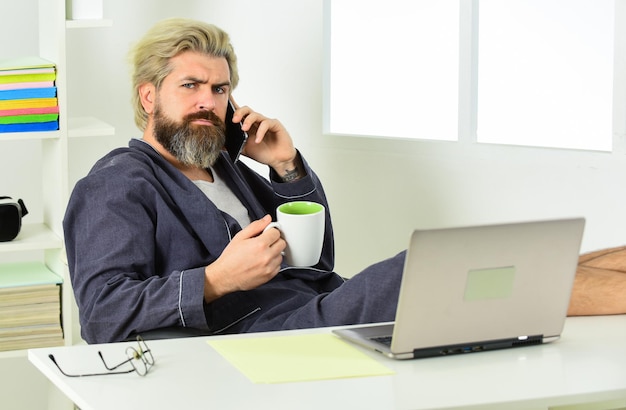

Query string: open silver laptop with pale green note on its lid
334 218 585 359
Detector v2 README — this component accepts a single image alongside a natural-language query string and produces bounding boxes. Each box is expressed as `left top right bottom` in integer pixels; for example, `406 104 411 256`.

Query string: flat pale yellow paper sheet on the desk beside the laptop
208 333 394 383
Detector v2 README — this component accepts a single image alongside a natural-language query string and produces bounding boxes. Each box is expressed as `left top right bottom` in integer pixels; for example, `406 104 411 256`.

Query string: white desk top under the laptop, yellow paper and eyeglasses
28 315 626 410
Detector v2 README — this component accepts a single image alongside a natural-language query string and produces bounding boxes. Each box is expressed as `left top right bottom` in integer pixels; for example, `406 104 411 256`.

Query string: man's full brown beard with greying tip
154 104 226 168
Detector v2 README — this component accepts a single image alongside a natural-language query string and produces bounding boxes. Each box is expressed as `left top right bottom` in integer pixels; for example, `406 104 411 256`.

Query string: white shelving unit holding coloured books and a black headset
0 0 115 409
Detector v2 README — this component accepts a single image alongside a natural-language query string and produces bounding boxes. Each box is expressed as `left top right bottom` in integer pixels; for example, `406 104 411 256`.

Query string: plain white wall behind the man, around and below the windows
62 0 626 276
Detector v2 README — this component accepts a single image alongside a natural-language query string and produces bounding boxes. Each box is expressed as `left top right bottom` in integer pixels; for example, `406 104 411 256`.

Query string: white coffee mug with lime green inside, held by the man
265 201 325 267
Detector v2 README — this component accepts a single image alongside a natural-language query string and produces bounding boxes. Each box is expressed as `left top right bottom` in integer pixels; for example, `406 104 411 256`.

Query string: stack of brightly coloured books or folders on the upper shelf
0 57 59 132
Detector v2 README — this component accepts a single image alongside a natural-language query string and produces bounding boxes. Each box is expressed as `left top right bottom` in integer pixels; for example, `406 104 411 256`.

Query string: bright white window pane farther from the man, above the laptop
477 0 614 150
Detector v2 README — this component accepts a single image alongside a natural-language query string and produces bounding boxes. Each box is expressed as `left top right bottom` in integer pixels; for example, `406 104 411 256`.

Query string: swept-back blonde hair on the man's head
130 18 239 131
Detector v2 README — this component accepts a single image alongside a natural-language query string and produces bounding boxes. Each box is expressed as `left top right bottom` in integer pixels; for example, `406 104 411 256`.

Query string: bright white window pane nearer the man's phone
326 0 459 140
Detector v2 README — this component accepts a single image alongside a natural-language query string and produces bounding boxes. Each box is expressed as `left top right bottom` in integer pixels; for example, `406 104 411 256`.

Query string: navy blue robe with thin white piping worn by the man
63 139 404 343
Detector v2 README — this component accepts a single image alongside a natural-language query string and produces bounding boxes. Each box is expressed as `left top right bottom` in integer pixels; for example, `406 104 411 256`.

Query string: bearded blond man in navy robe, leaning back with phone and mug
64 19 404 343
